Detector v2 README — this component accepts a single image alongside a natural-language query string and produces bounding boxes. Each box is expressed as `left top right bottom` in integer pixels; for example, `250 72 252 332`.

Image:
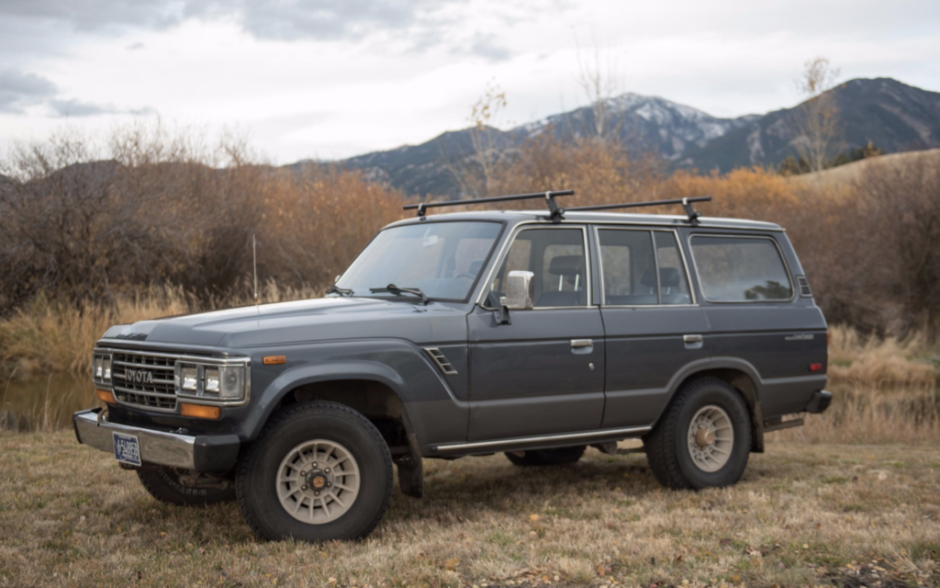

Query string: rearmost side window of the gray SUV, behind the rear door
692 235 793 302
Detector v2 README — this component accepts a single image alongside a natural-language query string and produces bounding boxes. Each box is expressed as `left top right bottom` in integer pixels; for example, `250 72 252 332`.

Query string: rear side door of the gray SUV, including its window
595 225 709 428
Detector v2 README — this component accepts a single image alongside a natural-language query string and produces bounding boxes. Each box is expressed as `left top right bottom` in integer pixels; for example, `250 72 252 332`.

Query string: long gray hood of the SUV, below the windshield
103 298 466 349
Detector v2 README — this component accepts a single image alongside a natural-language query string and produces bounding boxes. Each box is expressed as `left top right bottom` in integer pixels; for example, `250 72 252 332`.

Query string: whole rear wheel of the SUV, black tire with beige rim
643 378 751 490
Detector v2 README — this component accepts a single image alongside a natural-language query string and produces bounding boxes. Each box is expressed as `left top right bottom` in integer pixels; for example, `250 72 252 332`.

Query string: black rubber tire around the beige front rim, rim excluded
235 401 392 543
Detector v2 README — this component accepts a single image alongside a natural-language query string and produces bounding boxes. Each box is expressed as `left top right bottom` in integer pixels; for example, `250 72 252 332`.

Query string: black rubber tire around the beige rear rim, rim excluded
643 378 751 490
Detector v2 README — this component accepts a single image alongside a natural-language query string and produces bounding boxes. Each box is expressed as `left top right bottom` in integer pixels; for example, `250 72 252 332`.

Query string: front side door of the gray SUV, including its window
467 225 605 441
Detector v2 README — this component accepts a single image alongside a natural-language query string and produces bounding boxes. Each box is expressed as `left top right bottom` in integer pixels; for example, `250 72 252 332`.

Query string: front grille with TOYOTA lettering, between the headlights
111 351 176 411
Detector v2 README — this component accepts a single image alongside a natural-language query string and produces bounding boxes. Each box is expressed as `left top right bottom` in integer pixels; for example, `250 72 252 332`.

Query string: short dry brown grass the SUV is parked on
0 431 940 588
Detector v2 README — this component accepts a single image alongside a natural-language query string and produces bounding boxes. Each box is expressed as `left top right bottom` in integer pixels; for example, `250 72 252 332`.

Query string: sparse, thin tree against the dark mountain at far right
794 57 840 171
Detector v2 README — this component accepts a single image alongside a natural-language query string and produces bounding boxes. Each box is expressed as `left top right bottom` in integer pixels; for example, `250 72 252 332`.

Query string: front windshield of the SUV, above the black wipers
336 222 502 300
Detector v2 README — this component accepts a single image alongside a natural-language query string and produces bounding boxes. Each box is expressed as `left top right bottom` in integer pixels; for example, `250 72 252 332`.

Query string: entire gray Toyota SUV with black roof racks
74 192 831 541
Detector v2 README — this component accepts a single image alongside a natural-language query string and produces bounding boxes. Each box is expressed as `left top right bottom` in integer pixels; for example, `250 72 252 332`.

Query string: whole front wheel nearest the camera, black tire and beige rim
235 401 392 543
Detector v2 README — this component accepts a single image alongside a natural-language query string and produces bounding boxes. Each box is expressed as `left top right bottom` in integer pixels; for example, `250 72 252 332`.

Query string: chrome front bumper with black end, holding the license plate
72 408 241 473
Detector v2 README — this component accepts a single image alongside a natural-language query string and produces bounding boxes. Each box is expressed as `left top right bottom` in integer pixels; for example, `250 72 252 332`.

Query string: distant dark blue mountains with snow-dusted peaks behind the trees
289 78 940 197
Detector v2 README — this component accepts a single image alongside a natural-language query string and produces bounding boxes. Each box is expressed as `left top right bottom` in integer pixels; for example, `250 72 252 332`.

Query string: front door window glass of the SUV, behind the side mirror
488 228 588 308
